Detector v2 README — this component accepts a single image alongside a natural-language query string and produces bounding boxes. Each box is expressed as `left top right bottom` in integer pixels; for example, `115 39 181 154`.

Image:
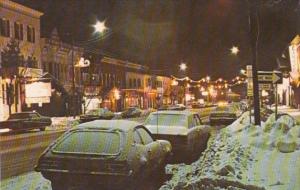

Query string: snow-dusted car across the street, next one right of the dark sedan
80 108 115 123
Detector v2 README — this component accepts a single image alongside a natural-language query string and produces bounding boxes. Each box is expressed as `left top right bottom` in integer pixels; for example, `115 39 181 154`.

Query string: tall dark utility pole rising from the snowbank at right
248 0 260 125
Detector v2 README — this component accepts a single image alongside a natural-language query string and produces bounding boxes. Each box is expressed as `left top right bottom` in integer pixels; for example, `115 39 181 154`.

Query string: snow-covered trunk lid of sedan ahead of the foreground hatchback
146 125 188 135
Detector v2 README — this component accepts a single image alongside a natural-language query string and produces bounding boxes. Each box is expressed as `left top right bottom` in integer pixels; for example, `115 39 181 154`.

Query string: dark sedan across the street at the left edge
0 112 52 131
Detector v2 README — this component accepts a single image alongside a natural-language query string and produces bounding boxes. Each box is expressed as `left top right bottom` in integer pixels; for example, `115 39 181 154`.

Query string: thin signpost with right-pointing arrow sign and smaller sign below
257 71 282 119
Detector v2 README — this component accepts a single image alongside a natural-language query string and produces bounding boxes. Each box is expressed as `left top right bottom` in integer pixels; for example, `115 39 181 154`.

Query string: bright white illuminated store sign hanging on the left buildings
25 82 51 104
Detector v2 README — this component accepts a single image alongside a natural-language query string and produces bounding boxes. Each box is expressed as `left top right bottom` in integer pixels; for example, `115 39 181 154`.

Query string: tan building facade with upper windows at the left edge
0 0 43 120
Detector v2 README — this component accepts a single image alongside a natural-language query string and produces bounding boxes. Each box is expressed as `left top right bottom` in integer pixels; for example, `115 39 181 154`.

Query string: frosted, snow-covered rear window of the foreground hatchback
53 130 120 155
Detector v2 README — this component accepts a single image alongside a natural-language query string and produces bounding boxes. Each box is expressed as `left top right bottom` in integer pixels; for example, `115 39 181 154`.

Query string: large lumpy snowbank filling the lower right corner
161 113 300 190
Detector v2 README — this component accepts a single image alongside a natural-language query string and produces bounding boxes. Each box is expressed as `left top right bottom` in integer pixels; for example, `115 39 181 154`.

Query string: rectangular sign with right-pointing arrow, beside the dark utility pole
257 71 282 84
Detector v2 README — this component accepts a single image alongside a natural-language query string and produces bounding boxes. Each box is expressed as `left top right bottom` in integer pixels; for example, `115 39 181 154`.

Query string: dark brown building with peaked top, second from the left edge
40 28 84 115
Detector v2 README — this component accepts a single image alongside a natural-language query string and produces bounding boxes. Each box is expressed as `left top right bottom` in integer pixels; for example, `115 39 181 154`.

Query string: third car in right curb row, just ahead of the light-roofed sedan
209 106 240 125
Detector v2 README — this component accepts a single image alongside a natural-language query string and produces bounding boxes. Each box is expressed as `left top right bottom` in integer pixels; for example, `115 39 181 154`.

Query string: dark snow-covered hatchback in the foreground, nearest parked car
35 120 172 190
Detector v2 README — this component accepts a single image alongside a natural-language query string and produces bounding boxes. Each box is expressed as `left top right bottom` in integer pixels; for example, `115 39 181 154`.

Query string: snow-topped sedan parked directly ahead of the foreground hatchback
144 111 209 160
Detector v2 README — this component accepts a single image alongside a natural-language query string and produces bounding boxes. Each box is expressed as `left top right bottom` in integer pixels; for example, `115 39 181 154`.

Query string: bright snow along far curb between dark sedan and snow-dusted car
51 117 79 130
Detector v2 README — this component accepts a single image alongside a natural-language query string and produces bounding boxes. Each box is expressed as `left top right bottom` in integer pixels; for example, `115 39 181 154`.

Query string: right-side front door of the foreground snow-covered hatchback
137 127 162 169
